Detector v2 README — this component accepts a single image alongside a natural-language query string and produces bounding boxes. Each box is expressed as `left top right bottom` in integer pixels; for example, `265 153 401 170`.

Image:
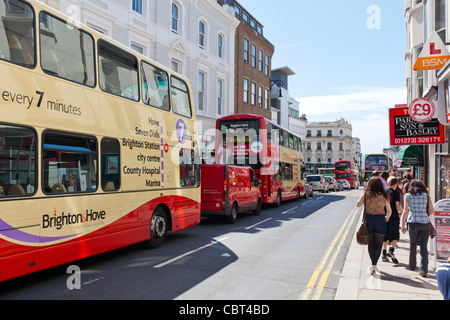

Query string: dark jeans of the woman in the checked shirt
408 223 430 273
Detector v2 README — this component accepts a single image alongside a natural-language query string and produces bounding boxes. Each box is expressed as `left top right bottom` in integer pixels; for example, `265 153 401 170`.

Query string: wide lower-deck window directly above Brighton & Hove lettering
42 132 97 194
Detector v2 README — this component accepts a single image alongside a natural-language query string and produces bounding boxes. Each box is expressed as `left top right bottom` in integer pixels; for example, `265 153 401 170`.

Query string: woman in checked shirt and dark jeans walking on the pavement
401 180 434 277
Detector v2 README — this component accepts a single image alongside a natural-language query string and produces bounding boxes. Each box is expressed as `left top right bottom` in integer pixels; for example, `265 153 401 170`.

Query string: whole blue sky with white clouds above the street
239 0 407 154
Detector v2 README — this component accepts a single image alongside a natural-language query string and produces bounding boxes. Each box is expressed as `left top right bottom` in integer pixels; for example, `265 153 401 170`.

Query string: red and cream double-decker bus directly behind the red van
215 115 305 205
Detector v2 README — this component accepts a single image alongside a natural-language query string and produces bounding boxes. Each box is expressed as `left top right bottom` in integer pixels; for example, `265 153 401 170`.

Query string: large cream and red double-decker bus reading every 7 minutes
0 0 200 281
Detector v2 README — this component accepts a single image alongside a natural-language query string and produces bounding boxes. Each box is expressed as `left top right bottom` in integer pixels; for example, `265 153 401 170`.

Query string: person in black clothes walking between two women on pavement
382 176 403 264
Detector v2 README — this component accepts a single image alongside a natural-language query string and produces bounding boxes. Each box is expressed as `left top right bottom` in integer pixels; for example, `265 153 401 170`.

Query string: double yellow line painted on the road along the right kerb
299 206 359 300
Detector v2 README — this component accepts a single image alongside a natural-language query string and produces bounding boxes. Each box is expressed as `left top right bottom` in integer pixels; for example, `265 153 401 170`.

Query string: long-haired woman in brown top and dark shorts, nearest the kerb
356 177 392 275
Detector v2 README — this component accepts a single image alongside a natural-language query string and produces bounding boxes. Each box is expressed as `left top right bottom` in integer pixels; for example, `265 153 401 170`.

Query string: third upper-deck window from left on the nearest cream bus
98 41 139 101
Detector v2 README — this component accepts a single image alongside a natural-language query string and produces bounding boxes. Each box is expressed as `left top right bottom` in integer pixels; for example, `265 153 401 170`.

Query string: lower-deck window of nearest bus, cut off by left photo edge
0 124 36 197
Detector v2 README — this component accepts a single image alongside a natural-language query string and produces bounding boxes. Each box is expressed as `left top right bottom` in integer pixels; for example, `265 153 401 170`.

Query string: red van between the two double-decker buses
201 164 262 223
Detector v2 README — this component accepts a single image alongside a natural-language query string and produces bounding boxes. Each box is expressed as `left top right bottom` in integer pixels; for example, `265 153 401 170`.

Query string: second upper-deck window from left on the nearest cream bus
39 12 95 87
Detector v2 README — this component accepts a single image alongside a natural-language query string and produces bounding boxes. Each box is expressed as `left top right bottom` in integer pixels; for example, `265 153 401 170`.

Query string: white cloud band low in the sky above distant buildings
297 87 406 153
